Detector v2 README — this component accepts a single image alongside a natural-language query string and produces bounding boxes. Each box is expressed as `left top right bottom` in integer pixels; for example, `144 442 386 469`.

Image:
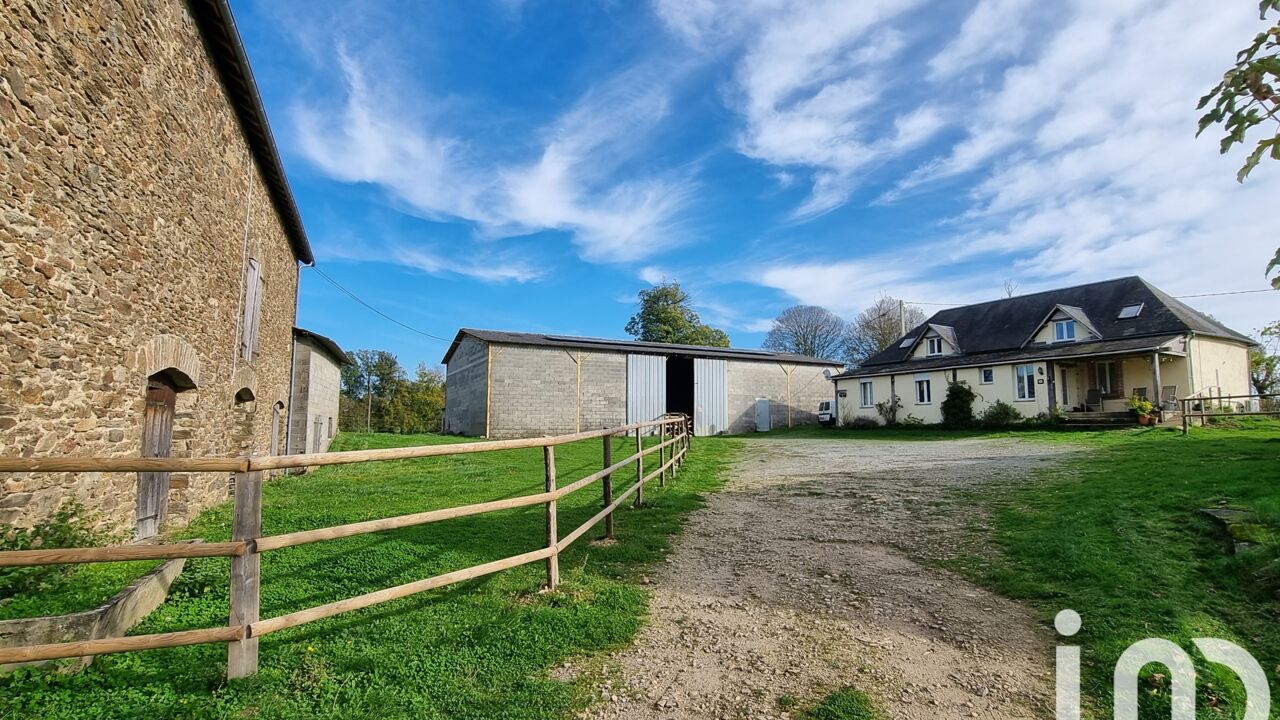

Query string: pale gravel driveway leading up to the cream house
588 438 1065 719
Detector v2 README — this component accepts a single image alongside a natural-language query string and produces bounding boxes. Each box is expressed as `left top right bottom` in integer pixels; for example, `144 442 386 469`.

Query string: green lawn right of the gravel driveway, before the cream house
957 421 1280 719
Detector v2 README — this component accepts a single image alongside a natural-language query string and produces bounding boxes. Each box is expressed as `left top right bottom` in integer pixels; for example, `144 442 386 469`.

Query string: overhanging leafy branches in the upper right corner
1196 0 1280 290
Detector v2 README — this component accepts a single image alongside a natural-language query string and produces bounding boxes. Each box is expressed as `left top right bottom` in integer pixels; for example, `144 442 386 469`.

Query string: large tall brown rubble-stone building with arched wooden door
0 0 312 537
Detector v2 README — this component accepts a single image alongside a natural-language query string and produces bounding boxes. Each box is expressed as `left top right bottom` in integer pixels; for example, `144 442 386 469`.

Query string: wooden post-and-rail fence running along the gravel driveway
0 415 691 678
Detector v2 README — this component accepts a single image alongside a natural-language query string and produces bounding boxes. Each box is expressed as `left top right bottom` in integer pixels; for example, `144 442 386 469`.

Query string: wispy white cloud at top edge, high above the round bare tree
654 0 946 219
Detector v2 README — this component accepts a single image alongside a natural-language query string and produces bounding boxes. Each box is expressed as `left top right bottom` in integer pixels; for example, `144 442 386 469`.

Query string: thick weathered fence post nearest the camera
227 471 262 679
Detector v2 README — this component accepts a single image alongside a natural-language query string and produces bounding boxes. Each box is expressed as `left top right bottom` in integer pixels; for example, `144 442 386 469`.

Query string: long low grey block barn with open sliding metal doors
443 328 841 438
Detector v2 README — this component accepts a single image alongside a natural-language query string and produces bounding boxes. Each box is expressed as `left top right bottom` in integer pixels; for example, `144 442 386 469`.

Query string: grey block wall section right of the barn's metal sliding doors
728 360 838 433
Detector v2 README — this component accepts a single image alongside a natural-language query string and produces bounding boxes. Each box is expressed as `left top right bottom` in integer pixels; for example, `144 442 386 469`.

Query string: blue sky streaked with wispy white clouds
232 0 1280 369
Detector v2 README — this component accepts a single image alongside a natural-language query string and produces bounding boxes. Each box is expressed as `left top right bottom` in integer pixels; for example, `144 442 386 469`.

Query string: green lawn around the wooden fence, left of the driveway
0 433 736 720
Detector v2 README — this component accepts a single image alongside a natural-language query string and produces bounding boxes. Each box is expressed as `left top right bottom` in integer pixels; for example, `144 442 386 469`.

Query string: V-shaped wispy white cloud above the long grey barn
293 46 692 269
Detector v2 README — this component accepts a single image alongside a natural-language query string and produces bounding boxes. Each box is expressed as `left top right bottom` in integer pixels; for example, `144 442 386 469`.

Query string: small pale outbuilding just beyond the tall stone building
288 328 351 455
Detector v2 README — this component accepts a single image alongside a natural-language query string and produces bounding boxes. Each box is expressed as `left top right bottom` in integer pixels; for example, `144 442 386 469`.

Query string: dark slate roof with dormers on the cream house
837 275 1253 378
